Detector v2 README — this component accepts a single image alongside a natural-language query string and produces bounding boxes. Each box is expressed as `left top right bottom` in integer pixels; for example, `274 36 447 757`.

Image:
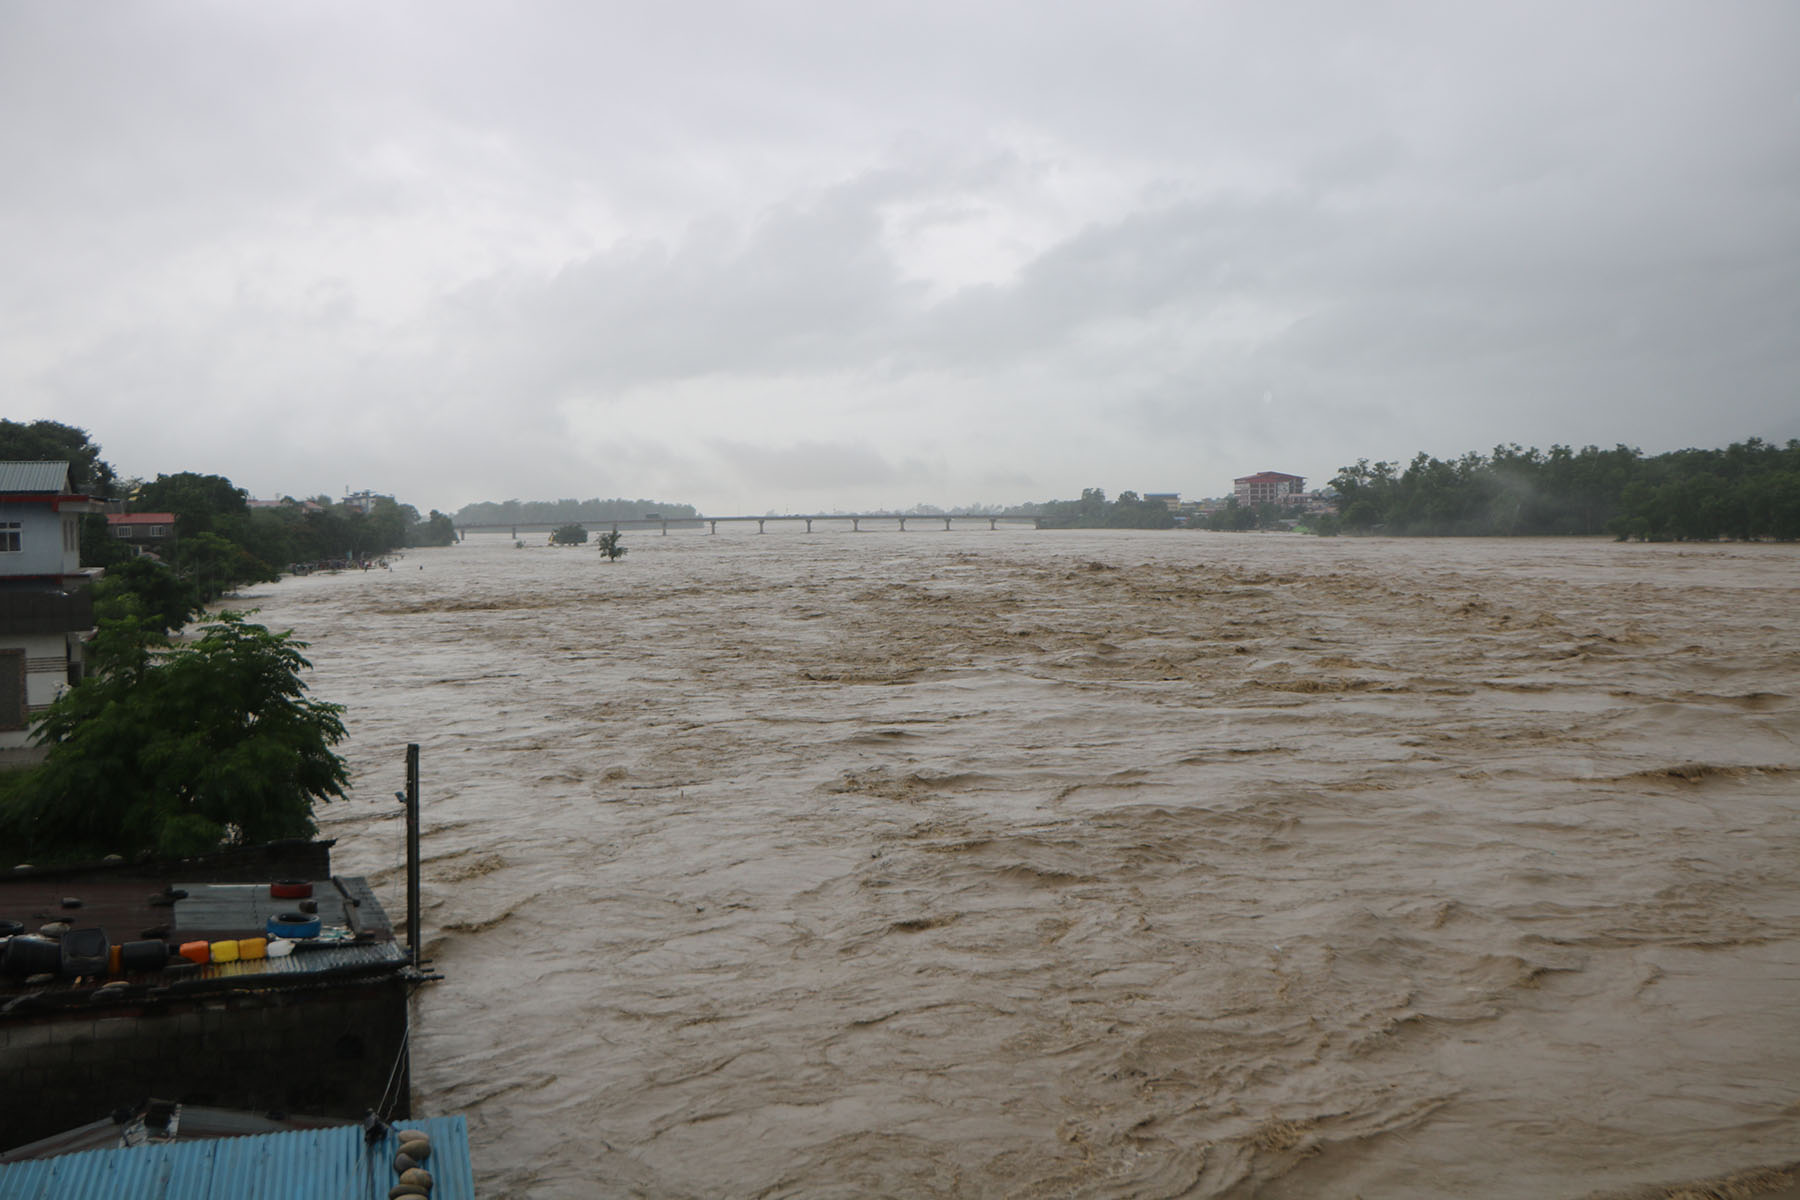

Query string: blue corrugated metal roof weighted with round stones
0 1117 475 1200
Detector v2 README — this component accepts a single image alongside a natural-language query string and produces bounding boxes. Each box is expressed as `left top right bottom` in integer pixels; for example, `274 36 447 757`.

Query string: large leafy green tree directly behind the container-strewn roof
0 612 349 860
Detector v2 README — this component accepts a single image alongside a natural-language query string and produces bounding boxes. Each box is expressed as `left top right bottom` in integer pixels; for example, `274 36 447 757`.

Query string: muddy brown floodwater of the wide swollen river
241 529 1800 1200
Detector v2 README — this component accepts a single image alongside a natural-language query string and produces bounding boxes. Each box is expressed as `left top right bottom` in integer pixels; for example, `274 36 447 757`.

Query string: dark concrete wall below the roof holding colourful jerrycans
0 975 412 1150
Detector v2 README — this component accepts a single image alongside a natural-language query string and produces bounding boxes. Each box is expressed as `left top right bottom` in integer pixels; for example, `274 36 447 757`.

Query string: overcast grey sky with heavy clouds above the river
0 0 1800 515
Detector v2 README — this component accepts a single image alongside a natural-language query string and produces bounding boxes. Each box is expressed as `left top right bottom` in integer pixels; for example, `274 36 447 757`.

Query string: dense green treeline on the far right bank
1321 437 1800 542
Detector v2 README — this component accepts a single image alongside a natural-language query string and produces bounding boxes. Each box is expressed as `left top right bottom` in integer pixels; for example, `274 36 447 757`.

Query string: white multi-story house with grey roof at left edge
0 462 103 750
